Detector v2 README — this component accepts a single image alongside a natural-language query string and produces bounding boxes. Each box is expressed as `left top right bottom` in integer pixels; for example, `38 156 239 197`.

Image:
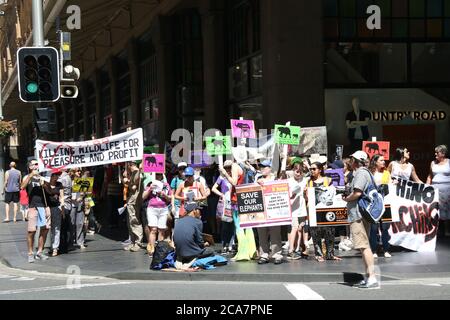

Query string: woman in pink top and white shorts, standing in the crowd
142 173 172 256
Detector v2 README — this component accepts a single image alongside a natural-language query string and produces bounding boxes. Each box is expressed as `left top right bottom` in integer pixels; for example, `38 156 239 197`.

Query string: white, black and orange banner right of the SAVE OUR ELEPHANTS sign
308 186 349 227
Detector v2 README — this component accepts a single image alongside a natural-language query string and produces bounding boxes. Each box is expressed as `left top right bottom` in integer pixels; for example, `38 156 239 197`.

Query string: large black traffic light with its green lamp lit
17 47 60 102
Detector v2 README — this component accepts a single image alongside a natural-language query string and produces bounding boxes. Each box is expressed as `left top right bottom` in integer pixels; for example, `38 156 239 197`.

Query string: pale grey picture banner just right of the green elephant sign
289 127 328 156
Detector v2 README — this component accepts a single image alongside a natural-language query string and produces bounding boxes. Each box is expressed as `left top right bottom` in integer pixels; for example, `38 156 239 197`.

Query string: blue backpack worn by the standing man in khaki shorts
358 169 385 223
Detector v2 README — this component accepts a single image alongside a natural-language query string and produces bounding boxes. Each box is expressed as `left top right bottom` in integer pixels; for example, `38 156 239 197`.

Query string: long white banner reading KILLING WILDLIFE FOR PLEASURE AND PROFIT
36 128 144 171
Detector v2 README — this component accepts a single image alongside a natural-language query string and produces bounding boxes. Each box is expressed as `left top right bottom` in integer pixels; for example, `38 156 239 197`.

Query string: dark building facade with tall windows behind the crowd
1 0 450 176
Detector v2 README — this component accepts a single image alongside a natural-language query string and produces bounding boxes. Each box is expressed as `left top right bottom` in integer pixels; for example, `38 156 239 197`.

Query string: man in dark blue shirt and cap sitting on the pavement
173 202 215 264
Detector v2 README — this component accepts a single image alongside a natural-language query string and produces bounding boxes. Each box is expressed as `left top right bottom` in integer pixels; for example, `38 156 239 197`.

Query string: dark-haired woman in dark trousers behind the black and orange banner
307 162 342 262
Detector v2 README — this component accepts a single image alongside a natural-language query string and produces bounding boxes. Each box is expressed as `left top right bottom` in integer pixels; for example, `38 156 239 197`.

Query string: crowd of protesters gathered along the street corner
5 145 450 287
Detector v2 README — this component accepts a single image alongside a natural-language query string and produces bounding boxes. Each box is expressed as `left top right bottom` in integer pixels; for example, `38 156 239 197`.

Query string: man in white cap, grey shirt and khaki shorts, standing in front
342 151 379 289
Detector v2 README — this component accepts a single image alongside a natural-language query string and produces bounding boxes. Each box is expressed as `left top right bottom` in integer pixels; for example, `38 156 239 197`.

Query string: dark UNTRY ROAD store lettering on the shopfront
372 111 447 122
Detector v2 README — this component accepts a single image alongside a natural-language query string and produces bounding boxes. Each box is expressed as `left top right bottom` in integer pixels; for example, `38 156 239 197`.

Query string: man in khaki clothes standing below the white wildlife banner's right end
124 162 144 252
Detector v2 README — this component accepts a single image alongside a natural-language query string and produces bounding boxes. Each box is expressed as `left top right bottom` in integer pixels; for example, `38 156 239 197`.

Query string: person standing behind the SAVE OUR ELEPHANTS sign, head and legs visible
257 160 283 265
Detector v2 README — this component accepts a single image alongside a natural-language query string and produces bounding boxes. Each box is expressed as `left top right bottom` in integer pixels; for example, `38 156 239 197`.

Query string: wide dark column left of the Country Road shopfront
261 0 325 128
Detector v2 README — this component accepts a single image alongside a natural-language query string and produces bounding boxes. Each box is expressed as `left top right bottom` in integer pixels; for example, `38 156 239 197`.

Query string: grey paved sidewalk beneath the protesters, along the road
0 205 450 282
